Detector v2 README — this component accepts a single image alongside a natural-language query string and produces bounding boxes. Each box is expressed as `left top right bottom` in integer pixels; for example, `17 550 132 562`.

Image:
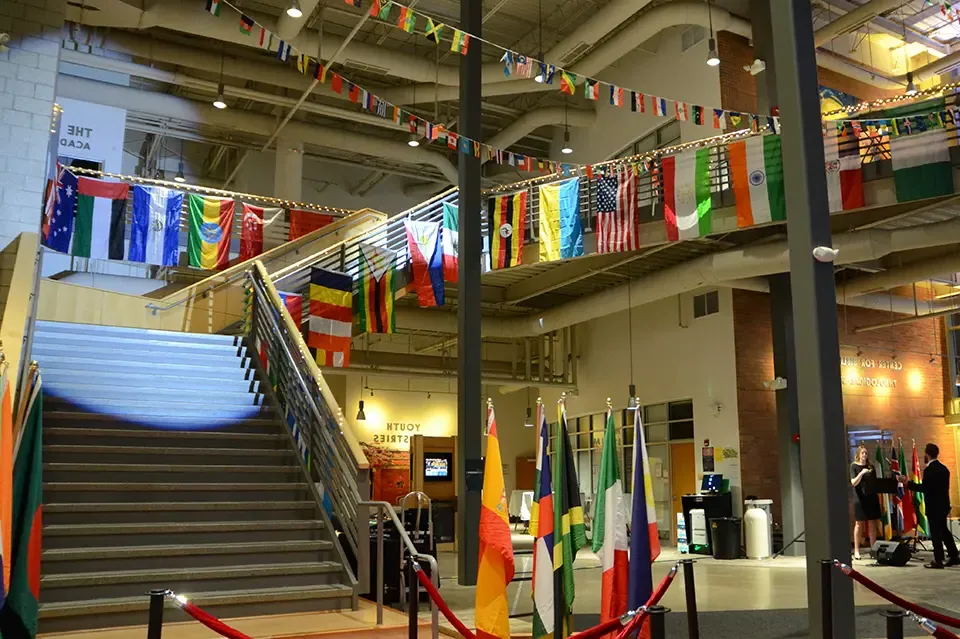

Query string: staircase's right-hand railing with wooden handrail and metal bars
249 261 370 566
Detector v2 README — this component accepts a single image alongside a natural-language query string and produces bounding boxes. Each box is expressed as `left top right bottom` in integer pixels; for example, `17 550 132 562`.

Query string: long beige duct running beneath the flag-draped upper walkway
397 210 960 339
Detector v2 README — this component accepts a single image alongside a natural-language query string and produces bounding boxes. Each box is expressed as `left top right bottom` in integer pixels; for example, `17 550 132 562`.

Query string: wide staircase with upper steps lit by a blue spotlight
32 322 355 633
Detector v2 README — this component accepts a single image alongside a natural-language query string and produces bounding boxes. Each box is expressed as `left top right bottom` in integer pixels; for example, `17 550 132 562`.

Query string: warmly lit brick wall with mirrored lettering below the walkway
733 290 960 521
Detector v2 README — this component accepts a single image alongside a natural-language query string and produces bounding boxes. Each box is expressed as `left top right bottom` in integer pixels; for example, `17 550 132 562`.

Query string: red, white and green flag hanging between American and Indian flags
660 149 712 242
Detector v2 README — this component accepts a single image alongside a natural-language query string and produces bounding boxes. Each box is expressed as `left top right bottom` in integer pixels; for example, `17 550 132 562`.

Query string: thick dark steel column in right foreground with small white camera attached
770 0 855 639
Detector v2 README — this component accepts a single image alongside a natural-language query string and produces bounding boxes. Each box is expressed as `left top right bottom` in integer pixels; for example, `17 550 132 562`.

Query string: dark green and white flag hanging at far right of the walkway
884 98 953 202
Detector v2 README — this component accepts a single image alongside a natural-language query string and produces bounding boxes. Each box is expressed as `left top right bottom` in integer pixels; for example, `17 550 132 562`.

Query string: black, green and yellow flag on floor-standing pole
553 403 587 637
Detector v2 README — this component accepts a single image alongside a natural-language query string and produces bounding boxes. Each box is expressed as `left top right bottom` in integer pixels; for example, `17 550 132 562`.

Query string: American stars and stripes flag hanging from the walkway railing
597 167 640 253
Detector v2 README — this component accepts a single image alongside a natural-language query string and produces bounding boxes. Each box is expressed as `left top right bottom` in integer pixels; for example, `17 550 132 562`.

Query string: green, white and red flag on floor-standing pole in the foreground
592 408 629 636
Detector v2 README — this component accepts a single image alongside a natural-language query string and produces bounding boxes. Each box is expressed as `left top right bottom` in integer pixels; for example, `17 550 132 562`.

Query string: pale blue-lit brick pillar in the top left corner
0 0 66 247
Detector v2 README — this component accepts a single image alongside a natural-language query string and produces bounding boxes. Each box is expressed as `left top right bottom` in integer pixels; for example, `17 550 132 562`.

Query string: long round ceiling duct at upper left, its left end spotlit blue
57 75 458 184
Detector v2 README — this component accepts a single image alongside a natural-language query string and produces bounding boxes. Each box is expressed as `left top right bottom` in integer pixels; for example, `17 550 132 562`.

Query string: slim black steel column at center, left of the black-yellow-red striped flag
457 2 483 586
